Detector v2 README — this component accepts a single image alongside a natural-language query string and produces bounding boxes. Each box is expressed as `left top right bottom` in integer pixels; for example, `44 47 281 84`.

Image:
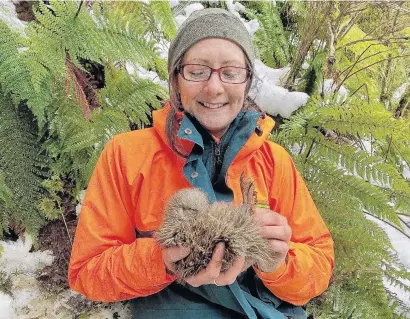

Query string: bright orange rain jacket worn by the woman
69 107 334 305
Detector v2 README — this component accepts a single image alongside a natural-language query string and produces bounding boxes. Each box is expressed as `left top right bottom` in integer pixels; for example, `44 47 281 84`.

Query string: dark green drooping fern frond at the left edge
0 94 49 238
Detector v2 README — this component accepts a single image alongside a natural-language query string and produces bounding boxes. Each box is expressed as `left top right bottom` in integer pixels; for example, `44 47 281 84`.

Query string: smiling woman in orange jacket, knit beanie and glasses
69 9 334 318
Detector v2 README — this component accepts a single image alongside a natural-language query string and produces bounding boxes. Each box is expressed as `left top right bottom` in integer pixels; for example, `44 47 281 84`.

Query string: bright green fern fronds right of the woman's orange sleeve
273 96 410 318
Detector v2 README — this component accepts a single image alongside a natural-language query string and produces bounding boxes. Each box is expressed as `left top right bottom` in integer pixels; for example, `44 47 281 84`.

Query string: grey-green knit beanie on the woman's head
168 8 255 74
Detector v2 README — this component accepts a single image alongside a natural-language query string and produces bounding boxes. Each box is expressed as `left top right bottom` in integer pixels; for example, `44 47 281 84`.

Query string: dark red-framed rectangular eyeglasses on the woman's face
179 64 250 84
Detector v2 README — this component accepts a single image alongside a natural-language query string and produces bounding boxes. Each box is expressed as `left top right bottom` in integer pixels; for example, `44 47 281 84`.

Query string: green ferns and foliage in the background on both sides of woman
0 1 410 319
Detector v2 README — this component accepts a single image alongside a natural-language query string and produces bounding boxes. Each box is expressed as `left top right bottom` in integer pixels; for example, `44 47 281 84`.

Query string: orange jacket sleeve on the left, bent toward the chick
68 140 175 302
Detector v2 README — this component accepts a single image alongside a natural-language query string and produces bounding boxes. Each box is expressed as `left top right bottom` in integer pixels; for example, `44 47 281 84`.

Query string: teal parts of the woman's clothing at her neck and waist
131 111 306 319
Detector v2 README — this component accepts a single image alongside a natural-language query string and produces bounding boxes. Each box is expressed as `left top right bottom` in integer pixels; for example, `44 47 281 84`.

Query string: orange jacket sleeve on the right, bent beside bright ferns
255 149 334 305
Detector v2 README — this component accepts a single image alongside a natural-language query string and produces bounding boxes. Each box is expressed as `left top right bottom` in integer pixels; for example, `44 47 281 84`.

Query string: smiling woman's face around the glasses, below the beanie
178 38 249 138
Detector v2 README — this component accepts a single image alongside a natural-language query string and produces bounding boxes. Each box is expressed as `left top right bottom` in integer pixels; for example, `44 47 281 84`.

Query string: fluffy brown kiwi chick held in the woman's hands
155 176 275 283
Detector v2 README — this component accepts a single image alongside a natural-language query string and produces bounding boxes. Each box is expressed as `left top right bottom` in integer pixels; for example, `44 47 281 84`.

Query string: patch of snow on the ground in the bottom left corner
0 235 131 319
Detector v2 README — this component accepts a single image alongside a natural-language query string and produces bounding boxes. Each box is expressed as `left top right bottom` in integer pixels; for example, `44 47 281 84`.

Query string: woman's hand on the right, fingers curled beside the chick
253 207 292 271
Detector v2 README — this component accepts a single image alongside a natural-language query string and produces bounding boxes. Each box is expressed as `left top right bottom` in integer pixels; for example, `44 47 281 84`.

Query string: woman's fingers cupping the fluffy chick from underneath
185 243 245 287
